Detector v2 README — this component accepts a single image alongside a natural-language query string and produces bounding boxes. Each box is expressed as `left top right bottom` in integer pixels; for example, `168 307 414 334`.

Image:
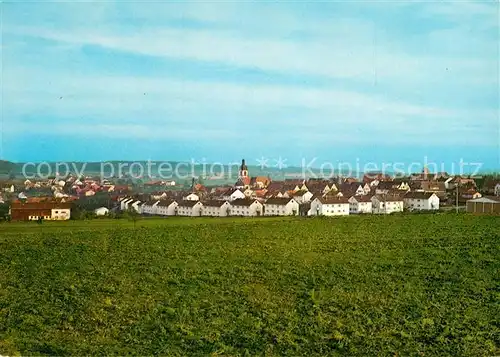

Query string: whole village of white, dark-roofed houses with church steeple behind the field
0 160 500 221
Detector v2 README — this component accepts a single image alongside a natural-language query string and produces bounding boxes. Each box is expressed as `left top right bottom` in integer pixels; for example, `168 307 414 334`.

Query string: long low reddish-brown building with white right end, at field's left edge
10 201 72 221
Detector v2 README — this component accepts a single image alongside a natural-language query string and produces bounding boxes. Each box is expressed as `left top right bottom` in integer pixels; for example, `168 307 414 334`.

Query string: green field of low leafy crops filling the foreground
0 214 500 356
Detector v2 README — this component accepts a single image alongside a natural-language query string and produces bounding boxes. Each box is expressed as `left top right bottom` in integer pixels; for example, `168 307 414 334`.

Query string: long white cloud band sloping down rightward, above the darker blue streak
5 19 495 86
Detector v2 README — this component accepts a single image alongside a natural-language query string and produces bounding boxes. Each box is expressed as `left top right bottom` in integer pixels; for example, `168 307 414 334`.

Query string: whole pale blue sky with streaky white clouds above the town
0 1 500 169
